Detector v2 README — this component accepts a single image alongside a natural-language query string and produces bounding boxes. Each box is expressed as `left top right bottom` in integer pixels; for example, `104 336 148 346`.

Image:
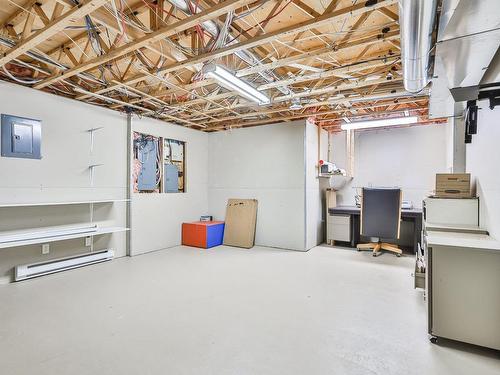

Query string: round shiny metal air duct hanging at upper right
399 0 437 93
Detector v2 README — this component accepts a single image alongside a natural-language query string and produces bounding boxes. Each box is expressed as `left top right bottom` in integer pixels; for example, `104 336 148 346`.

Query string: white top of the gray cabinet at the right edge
426 232 500 251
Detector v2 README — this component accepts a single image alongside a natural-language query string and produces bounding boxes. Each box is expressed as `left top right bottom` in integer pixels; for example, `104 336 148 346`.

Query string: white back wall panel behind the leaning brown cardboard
208 121 305 250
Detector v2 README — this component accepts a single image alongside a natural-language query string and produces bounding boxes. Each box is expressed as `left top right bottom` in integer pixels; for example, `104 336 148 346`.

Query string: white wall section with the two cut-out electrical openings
131 118 209 255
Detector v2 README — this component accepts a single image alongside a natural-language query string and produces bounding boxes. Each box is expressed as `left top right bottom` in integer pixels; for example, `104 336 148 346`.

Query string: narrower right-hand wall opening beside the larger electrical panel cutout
163 138 186 193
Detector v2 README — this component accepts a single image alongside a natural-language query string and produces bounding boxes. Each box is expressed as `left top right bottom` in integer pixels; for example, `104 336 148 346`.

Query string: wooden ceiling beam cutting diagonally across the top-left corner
0 0 108 66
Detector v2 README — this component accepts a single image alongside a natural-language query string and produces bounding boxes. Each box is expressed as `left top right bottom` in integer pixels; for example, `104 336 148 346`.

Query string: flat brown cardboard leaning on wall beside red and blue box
224 199 257 249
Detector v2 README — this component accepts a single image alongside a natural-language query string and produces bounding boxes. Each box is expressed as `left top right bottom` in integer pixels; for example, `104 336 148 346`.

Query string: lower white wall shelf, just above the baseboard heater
0 226 129 249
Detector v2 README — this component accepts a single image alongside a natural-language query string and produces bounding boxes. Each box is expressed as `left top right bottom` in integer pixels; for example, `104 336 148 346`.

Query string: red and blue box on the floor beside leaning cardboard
182 221 224 249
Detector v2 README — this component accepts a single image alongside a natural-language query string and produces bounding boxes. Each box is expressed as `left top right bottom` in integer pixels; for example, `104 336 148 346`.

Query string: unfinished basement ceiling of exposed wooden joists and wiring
0 0 444 131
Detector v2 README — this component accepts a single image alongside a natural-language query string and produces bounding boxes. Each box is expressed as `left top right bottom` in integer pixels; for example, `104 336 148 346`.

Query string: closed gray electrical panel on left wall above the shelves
2 114 42 159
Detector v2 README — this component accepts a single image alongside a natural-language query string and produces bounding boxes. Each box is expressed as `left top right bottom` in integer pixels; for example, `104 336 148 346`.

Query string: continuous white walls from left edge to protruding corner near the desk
0 83 348 278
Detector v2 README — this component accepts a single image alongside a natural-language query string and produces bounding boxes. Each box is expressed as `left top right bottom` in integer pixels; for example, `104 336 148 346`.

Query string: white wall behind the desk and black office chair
332 125 449 207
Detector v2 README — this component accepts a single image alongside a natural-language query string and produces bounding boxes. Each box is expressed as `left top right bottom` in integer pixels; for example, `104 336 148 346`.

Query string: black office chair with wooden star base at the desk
357 188 402 257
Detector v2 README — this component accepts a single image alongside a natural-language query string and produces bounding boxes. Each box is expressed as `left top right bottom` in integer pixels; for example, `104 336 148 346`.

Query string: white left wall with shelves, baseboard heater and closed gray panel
0 82 127 282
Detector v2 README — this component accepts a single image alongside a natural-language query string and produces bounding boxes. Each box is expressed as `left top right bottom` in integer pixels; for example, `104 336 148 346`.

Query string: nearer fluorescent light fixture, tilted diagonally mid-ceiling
203 64 271 104
